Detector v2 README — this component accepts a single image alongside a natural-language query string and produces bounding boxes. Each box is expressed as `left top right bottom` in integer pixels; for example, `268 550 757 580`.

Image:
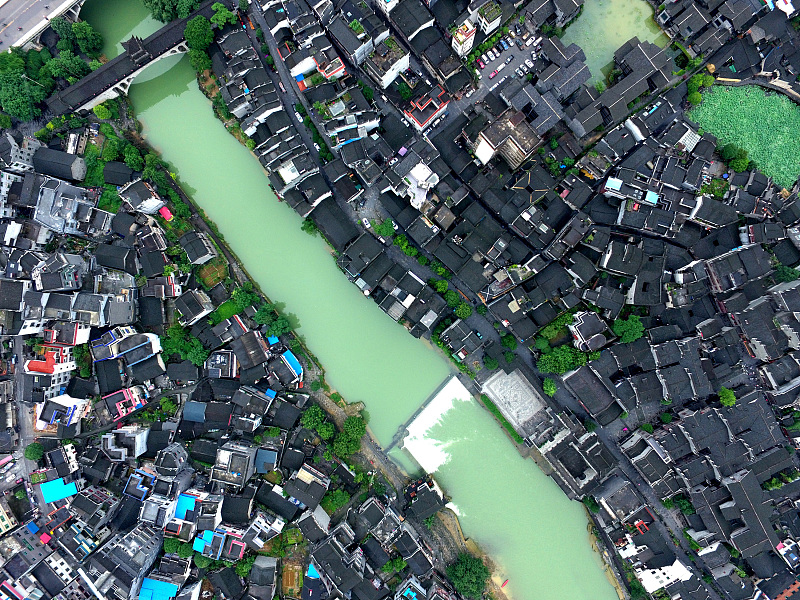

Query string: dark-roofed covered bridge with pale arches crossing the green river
47 0 223 115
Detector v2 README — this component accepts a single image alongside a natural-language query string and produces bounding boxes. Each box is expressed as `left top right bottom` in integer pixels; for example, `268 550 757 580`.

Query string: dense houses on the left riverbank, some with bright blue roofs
0 117 462 600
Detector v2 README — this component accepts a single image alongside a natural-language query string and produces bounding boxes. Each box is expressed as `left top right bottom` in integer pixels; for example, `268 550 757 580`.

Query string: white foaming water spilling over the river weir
403 375 471 473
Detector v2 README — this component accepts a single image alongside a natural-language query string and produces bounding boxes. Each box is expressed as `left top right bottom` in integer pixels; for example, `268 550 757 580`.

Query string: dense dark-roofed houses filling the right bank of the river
200 0 800 600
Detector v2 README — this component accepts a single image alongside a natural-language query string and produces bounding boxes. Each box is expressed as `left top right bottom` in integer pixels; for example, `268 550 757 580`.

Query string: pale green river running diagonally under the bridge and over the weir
81 0 616 600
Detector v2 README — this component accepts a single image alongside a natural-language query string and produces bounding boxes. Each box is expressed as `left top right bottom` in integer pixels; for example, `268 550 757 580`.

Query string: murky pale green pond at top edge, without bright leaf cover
561 0 677 84
